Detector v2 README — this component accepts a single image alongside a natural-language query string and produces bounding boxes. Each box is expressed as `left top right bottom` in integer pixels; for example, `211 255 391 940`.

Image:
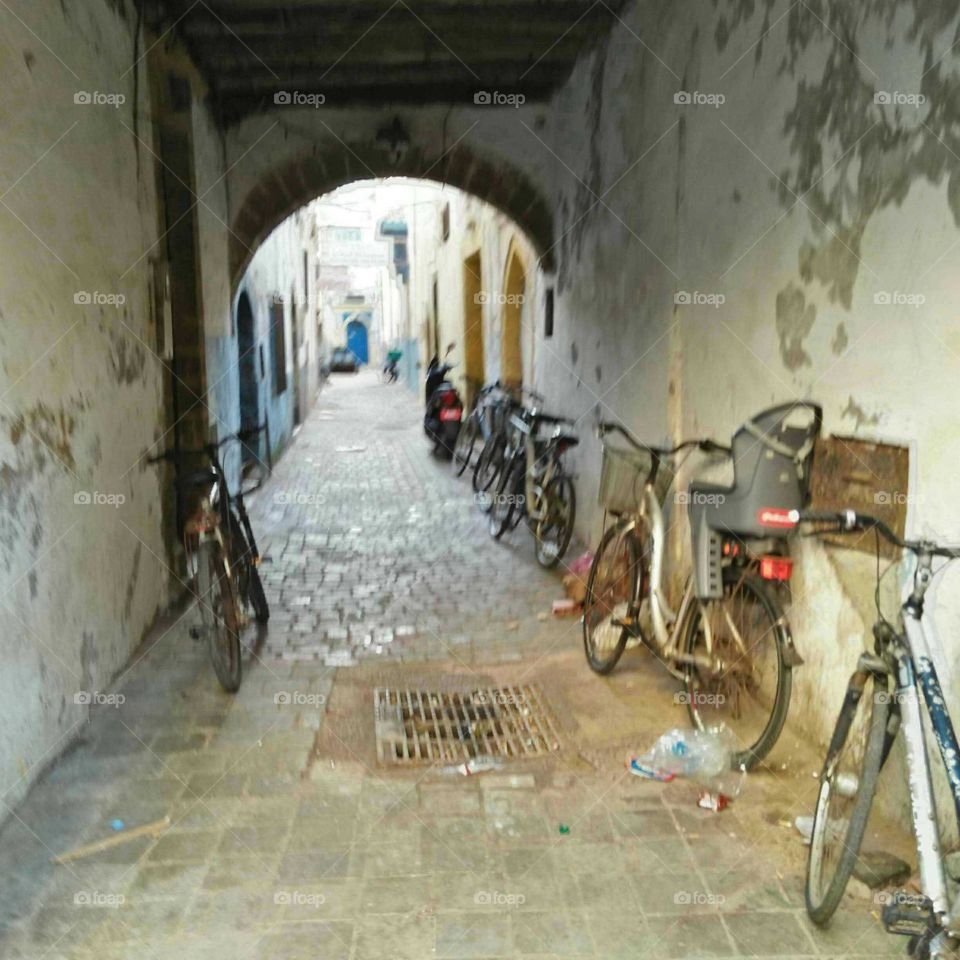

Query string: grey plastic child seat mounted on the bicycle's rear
687 401 823 600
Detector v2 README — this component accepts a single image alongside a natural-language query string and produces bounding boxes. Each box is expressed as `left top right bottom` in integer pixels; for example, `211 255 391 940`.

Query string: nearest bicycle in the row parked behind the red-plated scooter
489 410 580 569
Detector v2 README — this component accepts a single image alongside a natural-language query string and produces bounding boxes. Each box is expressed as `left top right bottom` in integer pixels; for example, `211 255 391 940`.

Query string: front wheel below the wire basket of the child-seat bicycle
583 523 642 675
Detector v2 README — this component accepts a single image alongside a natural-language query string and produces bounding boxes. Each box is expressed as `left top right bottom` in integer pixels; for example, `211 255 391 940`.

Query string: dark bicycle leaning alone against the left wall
148 427 270 693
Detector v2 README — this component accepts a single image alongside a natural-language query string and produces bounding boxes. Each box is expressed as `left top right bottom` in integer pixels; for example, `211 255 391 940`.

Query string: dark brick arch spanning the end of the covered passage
230 146 554 290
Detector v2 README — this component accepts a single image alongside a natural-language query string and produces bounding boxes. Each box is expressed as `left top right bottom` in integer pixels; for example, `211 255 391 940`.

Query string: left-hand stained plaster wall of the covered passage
0 0 167 813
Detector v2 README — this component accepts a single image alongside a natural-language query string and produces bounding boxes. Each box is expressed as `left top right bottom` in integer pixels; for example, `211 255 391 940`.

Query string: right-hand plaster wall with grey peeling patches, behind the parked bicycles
539 0 960 828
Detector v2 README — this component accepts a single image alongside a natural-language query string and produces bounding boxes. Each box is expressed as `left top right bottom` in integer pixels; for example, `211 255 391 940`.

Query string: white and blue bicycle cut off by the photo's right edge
796 510 960 958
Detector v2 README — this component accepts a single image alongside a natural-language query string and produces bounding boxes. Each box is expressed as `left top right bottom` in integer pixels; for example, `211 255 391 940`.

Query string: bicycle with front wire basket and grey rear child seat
583 403 821 769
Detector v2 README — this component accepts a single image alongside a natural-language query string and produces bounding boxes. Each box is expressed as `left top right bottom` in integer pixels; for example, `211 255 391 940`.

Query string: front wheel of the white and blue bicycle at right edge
804 673 891 927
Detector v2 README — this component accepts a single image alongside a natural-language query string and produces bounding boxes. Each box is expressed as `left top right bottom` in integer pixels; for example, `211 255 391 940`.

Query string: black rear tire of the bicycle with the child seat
680 567 793 770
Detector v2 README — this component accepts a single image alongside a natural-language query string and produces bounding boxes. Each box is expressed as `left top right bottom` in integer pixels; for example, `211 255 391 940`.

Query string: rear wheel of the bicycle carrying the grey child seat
680 567 793 770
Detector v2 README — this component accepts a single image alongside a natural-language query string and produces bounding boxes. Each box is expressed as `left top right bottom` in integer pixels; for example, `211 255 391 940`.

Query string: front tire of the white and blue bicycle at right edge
803 674 890 927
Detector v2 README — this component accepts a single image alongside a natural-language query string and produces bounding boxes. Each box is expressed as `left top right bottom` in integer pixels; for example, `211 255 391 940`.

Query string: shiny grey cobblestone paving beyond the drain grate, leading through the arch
253 373 560 666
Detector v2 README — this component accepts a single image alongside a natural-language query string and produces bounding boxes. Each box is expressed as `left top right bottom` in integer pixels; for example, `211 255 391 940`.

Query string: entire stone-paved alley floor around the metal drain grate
0 375 904 960
